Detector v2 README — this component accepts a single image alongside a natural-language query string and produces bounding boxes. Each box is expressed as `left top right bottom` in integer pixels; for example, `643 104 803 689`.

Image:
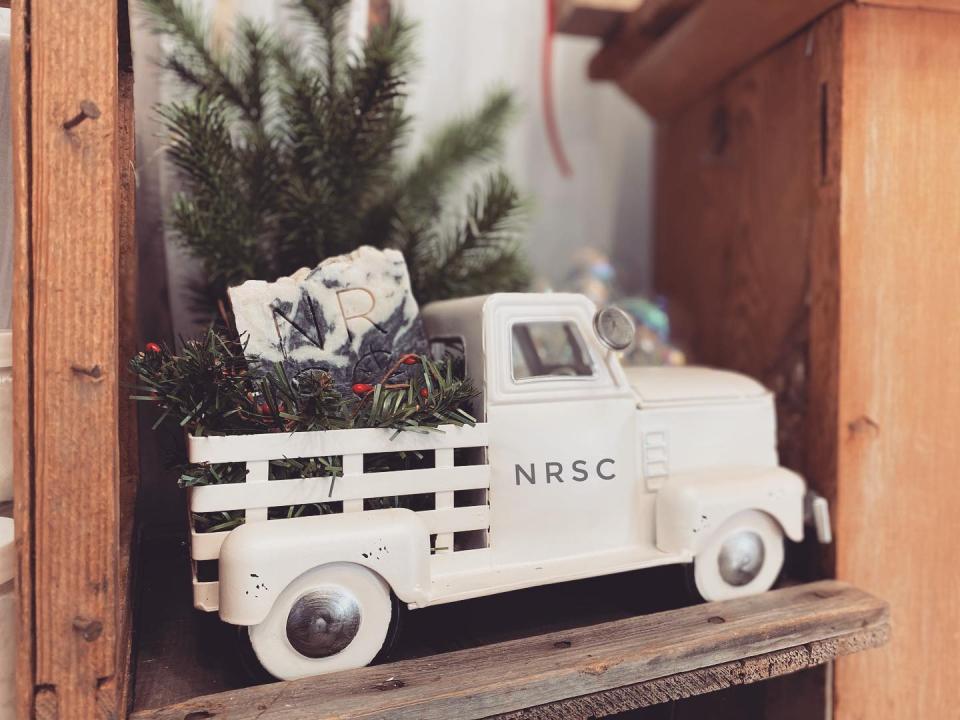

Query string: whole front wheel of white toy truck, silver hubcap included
693 510 783 600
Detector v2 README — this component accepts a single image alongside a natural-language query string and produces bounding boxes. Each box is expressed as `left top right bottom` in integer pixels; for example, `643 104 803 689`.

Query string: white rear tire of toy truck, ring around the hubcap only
247 563 401 680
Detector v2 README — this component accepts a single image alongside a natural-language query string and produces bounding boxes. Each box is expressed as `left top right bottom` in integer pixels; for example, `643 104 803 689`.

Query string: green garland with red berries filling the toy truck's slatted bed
130 328 477 532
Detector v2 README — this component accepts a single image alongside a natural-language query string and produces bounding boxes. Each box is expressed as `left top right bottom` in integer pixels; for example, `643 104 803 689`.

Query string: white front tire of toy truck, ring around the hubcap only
693 510 784 602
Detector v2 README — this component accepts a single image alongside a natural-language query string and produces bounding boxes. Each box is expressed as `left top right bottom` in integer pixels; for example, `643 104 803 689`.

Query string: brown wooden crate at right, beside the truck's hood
607 0 960 720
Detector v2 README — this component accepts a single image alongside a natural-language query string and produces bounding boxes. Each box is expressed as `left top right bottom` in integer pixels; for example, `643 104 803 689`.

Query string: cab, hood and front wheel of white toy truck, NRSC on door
423 293 805 599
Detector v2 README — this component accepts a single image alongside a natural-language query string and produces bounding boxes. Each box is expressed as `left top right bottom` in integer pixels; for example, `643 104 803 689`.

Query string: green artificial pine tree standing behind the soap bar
144 0 527 316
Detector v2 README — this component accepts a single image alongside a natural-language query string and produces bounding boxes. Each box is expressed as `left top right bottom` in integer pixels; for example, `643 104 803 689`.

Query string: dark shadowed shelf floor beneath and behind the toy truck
134 532 696 720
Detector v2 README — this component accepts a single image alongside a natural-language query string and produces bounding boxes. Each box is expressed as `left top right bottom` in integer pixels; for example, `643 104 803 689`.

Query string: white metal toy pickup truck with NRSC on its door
189 294 829 679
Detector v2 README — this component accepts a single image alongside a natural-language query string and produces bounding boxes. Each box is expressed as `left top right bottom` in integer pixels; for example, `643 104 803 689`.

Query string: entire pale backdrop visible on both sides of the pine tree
134 0 653 335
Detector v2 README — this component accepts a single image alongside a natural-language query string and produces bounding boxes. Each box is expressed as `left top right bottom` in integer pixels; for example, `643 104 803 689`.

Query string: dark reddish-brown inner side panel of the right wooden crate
654 14 840 496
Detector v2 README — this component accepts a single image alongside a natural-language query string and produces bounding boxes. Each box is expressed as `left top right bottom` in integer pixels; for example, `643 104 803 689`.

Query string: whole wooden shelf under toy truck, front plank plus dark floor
132 542 889 720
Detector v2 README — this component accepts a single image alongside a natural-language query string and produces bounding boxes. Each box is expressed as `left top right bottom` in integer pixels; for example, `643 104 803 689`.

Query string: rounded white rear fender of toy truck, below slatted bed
220 508 430 625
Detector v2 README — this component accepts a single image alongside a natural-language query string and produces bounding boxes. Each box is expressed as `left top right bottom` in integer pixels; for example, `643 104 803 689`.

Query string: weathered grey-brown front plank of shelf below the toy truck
133 581 889 720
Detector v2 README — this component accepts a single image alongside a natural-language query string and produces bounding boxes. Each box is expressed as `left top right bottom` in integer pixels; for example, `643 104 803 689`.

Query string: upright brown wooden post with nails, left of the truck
11 0 135 718
